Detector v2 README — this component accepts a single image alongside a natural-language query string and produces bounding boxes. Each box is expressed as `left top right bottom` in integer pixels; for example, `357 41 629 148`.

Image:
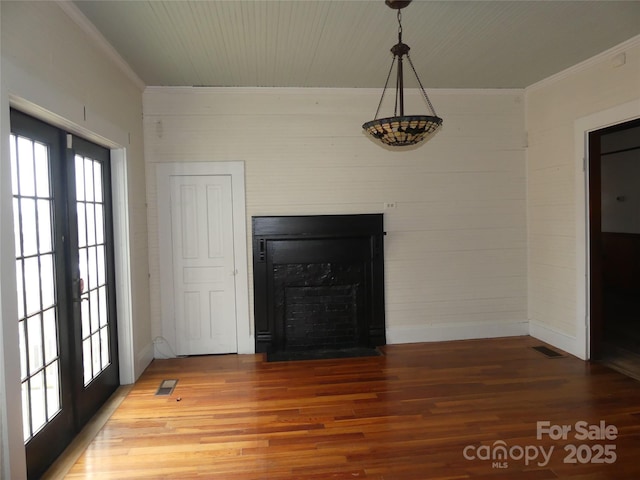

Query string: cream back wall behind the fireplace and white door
144 87 528 352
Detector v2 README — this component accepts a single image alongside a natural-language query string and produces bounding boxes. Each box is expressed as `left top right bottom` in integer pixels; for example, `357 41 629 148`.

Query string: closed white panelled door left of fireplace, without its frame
170 175 238 355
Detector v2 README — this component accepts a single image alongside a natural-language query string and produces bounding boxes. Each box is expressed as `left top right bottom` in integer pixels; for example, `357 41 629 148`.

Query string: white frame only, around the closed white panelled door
156 161 255 353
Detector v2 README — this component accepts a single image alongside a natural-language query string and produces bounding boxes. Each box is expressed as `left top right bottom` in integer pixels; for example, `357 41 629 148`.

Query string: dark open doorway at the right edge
589 119 640 377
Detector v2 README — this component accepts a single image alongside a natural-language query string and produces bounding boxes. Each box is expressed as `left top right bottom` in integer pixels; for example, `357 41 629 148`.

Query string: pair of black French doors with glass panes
11 110 119 478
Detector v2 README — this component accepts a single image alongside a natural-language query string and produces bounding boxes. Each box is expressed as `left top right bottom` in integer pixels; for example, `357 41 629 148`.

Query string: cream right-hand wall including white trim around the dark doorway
525 37 640 358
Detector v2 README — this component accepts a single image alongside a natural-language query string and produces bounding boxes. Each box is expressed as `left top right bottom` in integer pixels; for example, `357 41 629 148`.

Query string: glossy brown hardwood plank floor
56 337 640 480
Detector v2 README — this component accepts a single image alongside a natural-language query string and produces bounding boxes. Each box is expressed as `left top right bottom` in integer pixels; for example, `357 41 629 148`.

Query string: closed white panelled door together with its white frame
154 162 254 357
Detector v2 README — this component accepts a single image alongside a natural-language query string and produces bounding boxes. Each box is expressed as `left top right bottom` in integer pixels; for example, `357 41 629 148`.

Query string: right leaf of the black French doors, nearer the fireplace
67 137 120 425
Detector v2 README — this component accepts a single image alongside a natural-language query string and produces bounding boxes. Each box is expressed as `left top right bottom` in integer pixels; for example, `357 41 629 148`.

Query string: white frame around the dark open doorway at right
576 99 640 360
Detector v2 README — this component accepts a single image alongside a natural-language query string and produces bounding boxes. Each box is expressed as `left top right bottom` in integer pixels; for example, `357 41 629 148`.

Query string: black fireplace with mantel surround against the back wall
252 214 386 354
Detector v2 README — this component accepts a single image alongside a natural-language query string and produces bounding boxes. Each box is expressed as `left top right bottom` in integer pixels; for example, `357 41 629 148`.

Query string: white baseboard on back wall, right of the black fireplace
387 321 529 344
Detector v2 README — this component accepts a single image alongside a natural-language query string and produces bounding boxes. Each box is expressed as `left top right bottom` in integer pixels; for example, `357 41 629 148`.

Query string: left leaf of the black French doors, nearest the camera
10 111 74 477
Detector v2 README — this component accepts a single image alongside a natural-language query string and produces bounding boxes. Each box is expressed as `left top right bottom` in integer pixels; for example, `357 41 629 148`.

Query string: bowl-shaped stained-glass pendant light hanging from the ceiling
362 0 442 147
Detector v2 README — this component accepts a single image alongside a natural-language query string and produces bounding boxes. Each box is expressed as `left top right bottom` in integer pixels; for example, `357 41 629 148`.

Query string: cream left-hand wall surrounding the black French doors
0 1 152 480
